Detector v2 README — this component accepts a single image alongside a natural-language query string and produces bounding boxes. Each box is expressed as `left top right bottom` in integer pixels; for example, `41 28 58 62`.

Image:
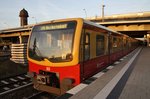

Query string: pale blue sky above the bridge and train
0 0 150 30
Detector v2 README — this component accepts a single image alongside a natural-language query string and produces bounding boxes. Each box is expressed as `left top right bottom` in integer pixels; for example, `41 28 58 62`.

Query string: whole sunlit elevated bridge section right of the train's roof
87 12 150 38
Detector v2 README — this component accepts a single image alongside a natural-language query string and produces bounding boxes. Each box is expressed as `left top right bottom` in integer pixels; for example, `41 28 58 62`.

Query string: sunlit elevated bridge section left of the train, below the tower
0 25 33 47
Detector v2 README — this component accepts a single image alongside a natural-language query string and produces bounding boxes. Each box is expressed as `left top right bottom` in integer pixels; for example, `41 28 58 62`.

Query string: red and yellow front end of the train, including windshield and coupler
27 20 81 95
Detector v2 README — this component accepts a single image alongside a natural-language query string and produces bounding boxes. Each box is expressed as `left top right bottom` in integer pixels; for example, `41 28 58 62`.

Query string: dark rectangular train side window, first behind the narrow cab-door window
96 35 105 56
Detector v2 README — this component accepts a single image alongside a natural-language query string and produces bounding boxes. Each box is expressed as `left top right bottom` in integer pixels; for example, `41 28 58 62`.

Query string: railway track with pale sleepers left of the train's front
0 73 33 96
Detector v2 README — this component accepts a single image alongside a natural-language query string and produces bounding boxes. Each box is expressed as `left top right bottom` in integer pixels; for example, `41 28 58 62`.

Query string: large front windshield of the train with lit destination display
28 22 76 62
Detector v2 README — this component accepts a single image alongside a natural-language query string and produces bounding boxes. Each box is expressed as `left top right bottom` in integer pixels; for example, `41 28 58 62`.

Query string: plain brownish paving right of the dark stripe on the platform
119 48 150 99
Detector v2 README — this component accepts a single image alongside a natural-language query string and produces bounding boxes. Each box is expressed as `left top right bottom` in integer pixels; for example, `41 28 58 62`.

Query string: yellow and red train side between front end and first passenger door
80 24 109 80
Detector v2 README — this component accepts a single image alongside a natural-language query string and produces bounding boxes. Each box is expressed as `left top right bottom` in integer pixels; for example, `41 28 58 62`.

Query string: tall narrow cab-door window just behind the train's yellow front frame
84 33 90 61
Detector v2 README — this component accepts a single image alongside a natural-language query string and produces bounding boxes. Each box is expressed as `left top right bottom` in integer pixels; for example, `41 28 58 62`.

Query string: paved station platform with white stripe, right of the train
58 47 150 99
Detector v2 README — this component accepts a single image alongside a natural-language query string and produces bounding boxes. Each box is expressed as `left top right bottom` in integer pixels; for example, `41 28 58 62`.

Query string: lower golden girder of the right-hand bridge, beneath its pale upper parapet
97 20 150 38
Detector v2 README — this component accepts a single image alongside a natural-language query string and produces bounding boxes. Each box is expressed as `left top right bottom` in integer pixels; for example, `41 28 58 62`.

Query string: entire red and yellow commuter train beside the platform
27 18 139 95
